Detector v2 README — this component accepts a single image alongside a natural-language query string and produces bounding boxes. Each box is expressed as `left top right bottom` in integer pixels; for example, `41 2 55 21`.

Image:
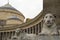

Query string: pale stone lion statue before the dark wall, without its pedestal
41 13 58 35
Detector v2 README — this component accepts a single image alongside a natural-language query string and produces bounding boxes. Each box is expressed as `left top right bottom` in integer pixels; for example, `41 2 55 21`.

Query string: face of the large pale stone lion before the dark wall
43 13 55 27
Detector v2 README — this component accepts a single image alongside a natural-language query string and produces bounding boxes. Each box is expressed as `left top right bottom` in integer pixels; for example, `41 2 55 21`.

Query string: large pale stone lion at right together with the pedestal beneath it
38 13 60 40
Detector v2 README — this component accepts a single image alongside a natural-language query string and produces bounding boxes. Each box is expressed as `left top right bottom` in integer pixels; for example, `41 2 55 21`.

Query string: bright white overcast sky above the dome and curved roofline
0 0 43 18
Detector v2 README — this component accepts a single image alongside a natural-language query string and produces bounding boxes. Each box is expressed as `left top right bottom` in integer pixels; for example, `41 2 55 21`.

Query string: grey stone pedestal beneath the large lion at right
38 34 60 40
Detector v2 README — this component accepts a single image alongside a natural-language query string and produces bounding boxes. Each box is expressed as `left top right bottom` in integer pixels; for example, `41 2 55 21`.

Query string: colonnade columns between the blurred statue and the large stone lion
24 22 42 34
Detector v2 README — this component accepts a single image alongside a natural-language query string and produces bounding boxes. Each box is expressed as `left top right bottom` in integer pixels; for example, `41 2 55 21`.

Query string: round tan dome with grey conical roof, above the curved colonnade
0 3 25 24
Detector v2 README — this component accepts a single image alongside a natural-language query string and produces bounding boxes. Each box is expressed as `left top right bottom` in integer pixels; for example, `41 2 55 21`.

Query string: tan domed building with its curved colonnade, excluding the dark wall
0 3 42 40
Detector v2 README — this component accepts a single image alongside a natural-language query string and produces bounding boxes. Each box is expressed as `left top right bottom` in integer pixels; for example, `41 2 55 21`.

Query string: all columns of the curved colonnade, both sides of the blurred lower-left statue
0 22 42 40
